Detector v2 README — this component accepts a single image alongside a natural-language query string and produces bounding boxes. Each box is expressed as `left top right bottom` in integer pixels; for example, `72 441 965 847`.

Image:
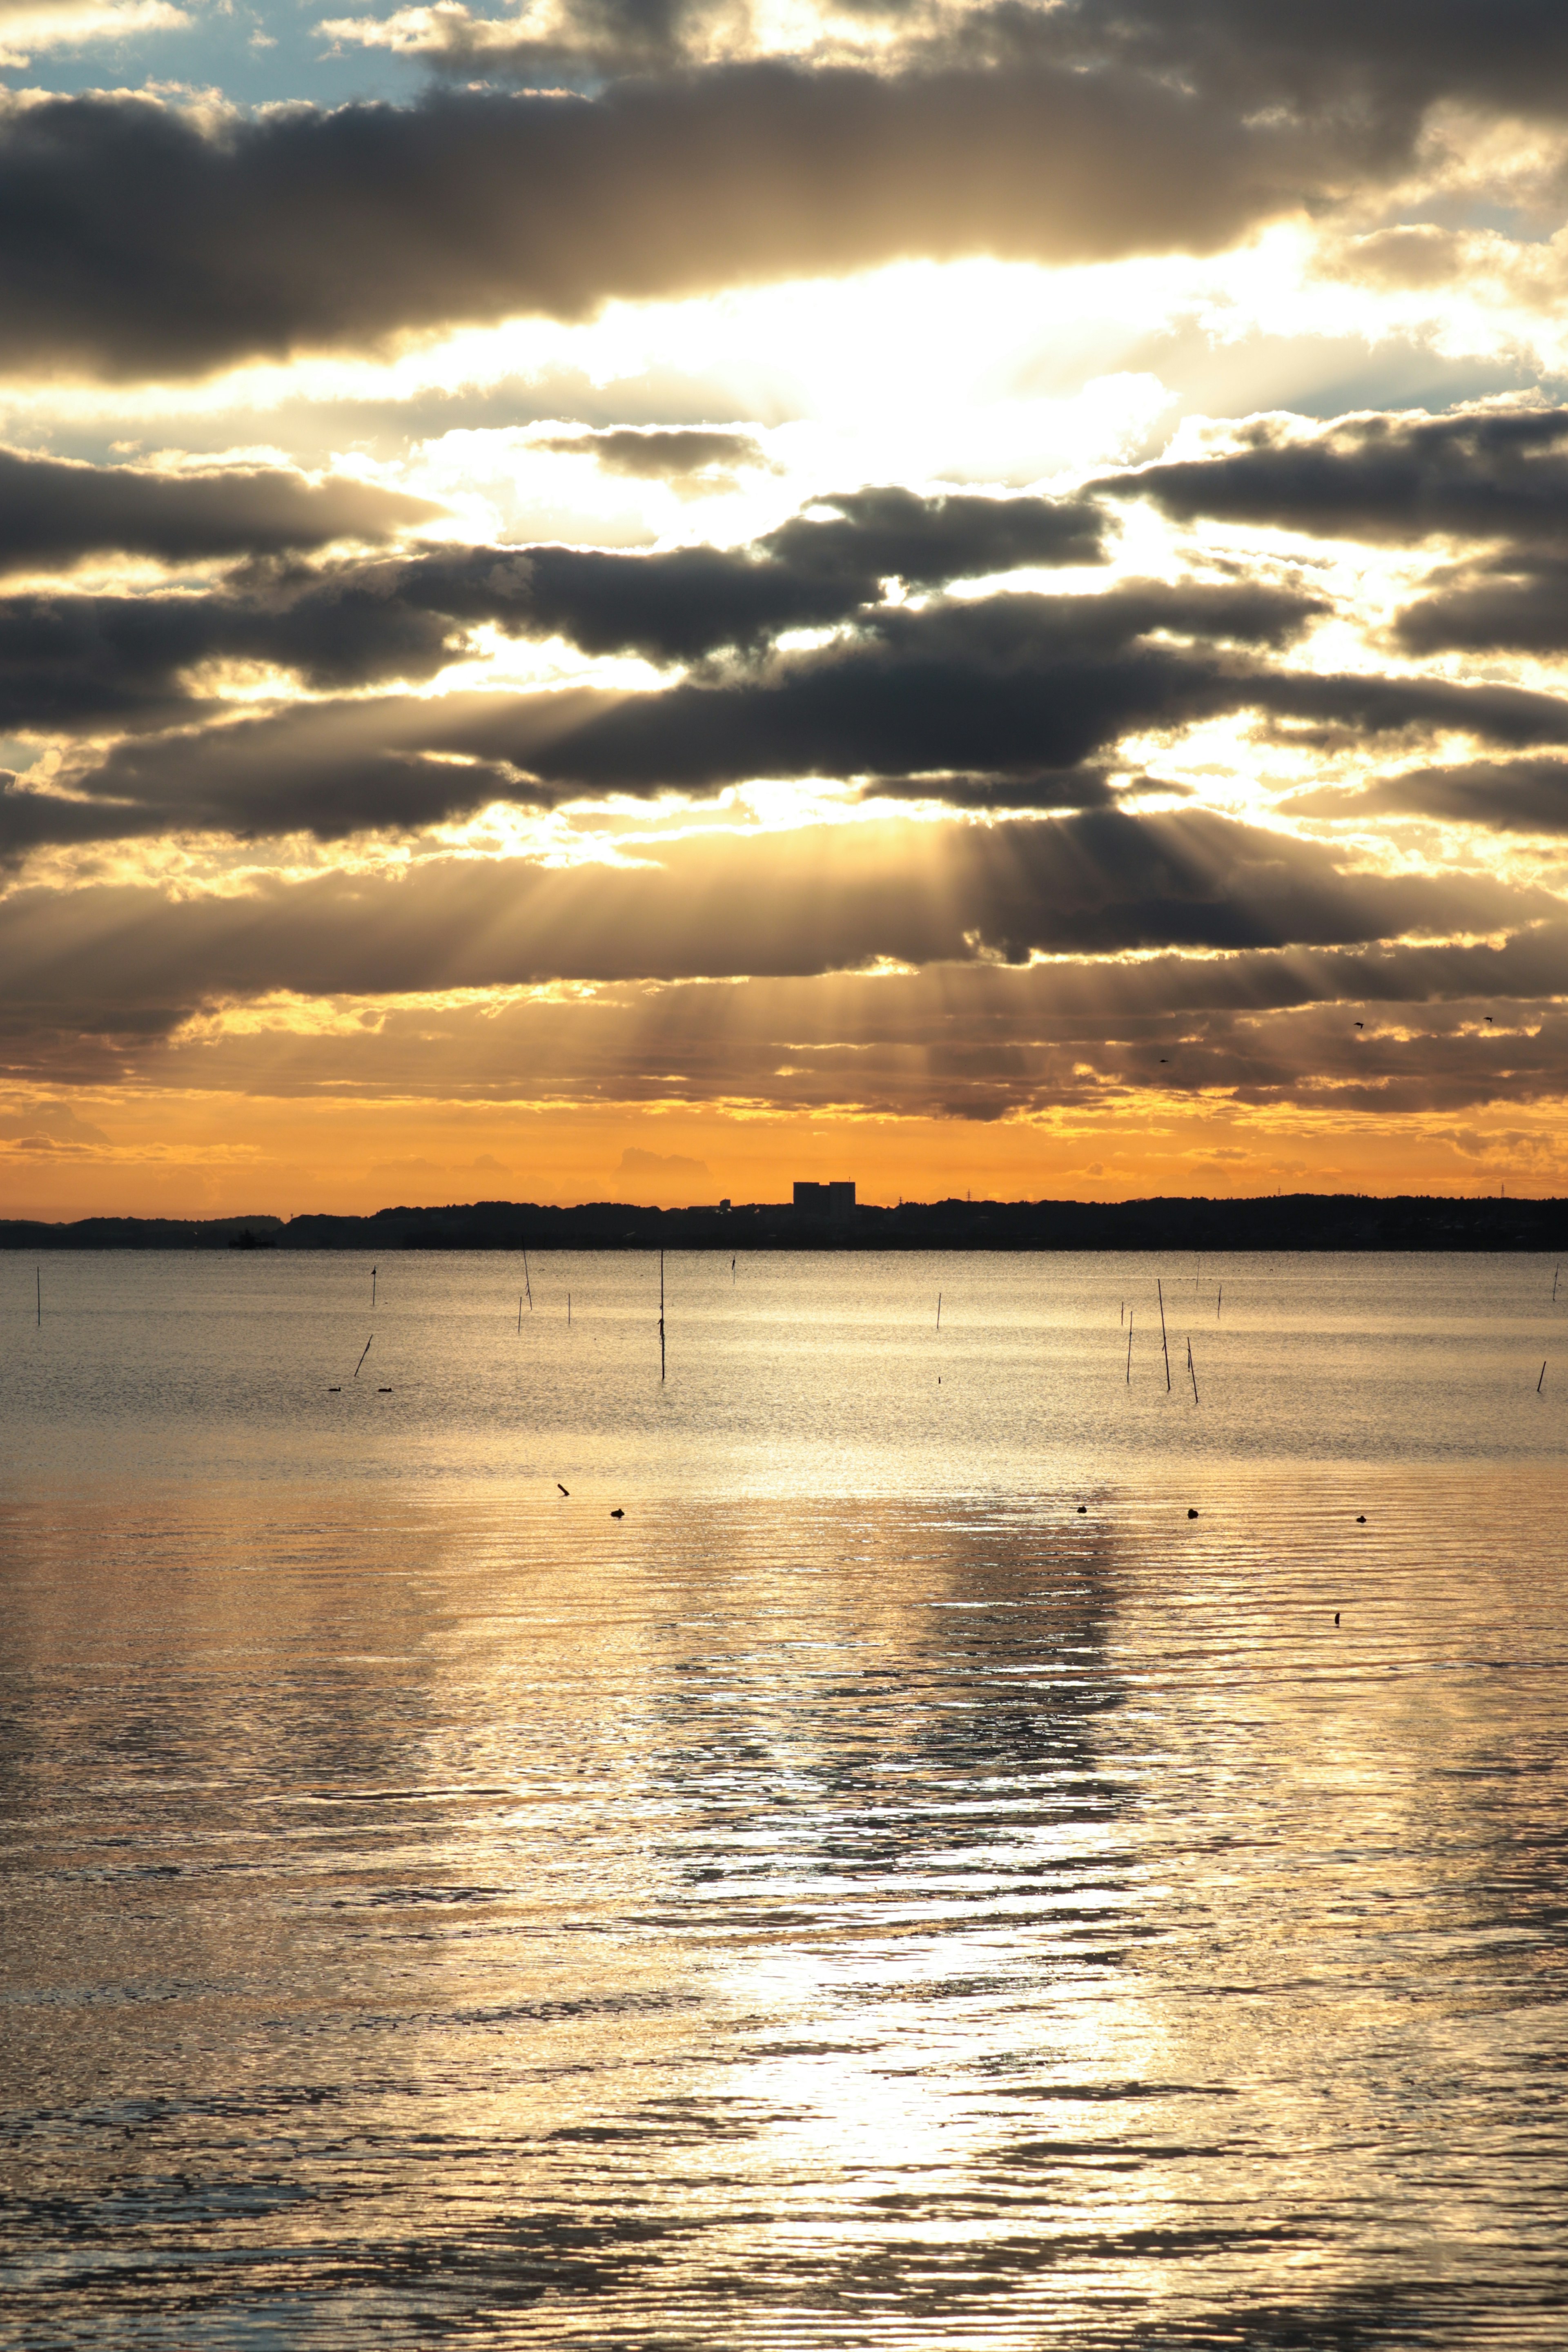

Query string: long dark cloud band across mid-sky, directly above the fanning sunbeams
27 564 1568 854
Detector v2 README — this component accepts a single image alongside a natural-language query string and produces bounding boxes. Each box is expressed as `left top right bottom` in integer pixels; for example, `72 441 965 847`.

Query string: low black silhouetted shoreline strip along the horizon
0 1192 1568 1256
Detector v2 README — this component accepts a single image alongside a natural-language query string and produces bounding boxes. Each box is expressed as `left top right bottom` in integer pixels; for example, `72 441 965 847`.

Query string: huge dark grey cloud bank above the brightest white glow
0 64 1335 379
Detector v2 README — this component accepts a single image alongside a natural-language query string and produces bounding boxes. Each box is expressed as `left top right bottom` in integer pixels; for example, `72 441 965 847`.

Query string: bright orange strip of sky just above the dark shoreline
0 1091 1568 1223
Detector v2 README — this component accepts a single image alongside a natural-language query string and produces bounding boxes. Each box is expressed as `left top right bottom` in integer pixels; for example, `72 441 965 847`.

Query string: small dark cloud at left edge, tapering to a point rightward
0 449 440 572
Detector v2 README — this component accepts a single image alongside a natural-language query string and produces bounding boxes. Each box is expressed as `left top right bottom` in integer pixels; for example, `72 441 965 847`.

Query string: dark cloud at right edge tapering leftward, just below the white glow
1091 409 1568 543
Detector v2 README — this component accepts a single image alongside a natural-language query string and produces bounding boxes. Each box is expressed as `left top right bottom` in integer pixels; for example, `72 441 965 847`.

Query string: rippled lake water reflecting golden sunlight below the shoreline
0 1254 1568 2352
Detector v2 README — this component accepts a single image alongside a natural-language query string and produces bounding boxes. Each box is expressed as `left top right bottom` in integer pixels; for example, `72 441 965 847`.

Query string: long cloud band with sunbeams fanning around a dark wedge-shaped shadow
0 809 1561 1070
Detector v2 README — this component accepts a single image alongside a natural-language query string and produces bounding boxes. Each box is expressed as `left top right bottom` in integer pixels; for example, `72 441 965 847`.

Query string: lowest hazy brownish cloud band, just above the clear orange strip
12 896 1568 1124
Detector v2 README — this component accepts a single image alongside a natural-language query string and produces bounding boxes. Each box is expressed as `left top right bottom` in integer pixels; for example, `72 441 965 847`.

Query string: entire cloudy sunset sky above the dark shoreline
0 0 1568 1218
